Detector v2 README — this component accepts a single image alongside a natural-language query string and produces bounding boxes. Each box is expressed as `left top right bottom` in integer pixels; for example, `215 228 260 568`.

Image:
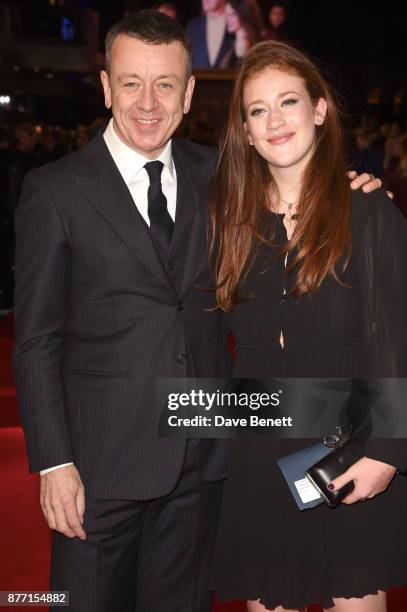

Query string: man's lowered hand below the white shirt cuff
40 465 86 540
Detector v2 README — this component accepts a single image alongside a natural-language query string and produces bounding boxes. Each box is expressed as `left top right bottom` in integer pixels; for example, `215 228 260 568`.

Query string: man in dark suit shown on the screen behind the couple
187 0 235 69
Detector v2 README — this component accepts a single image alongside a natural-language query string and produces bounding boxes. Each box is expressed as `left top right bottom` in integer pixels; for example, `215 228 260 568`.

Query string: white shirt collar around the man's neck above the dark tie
103 118 175 185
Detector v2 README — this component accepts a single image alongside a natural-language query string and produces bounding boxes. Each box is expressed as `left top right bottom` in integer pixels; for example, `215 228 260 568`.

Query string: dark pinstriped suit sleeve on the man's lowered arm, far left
13 171 73 472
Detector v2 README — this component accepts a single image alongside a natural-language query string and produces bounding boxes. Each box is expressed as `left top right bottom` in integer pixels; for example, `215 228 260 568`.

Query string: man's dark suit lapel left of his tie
73 134 171 287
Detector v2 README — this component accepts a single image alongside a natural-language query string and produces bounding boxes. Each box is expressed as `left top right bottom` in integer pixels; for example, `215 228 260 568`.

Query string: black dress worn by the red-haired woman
210 191 407 609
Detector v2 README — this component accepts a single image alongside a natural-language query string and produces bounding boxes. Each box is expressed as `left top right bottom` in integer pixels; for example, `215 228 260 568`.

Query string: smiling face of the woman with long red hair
243 67 326 178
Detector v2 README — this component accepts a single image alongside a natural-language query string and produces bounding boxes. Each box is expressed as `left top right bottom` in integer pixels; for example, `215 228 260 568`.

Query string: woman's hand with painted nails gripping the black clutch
329 457 396 504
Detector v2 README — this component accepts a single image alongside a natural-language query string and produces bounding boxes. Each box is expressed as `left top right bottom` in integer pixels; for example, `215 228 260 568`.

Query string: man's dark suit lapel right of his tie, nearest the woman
171 141 208 294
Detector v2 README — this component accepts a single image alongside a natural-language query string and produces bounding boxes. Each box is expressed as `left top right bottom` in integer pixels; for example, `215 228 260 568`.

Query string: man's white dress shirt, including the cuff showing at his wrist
40 119 177 476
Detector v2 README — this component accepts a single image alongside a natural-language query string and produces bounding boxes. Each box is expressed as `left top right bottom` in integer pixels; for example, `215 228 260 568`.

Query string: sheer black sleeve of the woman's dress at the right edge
366 191 407 473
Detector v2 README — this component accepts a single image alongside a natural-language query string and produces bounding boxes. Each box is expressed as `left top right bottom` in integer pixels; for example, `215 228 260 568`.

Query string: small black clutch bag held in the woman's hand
305 427 365 508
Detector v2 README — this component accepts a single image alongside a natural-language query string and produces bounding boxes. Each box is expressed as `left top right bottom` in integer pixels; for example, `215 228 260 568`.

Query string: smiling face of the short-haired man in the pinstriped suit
101 34 198 159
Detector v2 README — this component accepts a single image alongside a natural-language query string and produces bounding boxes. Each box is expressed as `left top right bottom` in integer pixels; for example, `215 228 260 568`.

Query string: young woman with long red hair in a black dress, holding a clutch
211 41 407 612
